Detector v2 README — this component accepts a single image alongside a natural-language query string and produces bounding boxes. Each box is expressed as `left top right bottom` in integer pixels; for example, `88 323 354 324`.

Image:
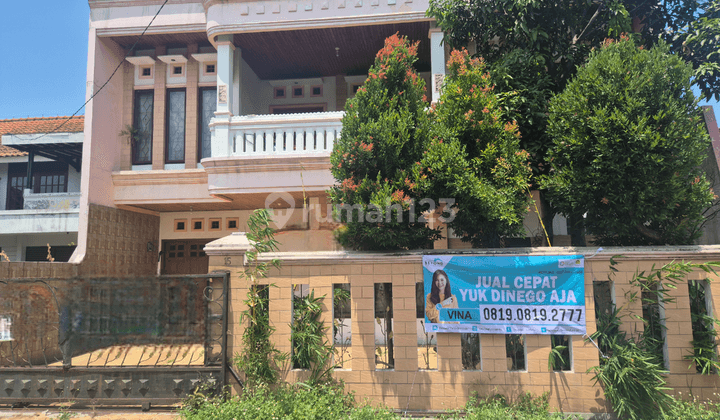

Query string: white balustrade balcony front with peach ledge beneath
202 111 344 205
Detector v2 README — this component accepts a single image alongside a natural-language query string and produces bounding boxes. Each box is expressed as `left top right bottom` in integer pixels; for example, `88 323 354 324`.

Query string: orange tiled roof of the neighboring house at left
0 115 85 157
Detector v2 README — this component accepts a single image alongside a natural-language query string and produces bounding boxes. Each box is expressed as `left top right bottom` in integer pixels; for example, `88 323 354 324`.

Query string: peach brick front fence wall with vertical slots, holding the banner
210 246 720 413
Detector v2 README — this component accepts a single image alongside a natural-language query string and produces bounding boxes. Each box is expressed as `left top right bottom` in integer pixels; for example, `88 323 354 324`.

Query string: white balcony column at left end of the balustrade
210 35 238 157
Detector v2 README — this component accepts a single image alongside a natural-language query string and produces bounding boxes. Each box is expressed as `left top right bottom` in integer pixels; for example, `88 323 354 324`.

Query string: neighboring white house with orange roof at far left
0 116 84 261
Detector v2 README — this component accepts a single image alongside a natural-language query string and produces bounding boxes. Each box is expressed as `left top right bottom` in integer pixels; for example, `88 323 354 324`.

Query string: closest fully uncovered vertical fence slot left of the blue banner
375 283 395 370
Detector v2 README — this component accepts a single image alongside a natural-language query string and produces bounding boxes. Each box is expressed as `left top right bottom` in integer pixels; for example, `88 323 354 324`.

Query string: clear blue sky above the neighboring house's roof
0 0 720 123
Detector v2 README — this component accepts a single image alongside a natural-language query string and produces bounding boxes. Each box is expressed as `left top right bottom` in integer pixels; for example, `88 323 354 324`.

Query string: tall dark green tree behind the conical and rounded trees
428 0 720 238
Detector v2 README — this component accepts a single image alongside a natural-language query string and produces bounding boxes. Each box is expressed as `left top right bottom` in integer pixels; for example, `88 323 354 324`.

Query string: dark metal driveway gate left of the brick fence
0 272 229 407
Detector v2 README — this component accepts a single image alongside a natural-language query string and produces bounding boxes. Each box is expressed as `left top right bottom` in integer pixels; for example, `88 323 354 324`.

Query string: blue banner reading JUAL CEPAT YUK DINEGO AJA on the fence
423 255 586 335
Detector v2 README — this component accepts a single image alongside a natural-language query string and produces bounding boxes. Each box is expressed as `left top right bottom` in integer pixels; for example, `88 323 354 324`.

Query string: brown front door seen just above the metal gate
161 239 211 274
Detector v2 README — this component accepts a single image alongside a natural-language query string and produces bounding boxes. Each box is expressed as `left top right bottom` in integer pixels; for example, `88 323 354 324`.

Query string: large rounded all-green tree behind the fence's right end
544 37 714 245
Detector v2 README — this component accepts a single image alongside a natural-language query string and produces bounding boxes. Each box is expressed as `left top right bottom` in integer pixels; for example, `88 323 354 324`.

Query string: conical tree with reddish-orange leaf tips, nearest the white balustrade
330 34 439 250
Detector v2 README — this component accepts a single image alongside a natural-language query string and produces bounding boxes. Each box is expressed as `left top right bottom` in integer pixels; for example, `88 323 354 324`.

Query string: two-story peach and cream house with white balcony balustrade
79 0 445 274
